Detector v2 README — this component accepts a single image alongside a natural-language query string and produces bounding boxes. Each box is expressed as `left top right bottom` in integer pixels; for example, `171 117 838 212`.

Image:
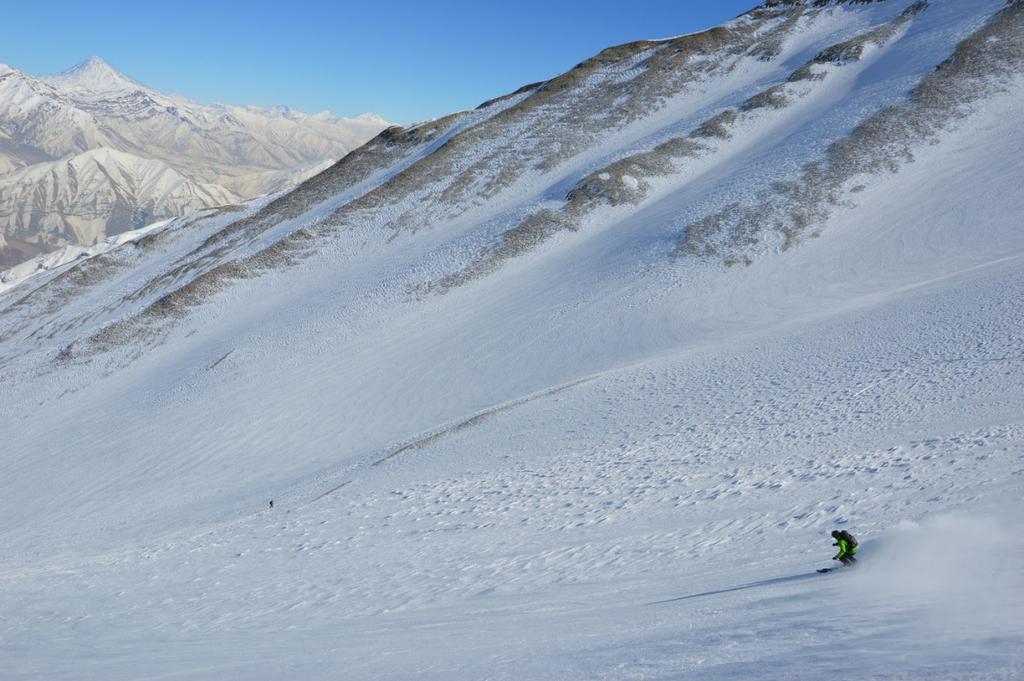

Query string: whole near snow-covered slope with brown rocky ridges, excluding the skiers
0 0 1024 681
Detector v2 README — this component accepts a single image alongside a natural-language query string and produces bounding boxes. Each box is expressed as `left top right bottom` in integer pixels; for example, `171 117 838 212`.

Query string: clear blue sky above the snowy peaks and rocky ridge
6 0 760 123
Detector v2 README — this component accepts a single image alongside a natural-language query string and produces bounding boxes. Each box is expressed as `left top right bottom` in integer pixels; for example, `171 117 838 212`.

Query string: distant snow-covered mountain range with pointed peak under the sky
0 57 389 266
